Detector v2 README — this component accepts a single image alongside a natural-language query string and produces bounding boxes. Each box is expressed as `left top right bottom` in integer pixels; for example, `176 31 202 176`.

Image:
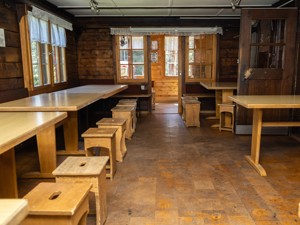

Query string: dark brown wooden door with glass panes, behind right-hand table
236 8 297 125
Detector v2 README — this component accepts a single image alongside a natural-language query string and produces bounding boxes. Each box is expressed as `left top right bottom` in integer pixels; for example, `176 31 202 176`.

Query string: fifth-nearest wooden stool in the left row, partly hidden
111 106 134 140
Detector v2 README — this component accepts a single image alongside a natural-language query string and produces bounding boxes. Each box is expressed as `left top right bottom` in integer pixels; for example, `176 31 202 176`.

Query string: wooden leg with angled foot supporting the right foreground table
245 109 267 176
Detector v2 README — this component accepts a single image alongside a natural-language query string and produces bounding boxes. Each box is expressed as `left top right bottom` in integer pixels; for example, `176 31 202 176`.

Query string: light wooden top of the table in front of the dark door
229 95 300 109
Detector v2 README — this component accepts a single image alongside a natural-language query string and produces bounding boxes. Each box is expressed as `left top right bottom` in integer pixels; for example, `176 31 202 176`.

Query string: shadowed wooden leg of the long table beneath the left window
57 111 85 155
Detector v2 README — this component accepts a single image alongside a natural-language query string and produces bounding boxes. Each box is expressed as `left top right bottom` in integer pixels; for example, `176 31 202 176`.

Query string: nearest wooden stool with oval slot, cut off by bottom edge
22 183 92 225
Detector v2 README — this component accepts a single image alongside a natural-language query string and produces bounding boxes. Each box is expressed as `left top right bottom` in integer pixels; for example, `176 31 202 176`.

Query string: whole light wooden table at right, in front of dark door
229 95 300 176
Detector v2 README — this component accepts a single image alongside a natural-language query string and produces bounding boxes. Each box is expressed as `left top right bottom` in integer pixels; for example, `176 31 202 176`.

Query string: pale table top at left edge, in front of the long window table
0 112 67 154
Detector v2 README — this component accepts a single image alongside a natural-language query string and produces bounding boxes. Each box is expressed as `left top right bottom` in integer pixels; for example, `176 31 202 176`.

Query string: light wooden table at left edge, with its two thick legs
0 112 67 198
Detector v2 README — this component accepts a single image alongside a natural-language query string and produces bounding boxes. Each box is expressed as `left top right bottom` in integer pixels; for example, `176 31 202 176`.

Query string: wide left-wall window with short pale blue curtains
25 13 67 92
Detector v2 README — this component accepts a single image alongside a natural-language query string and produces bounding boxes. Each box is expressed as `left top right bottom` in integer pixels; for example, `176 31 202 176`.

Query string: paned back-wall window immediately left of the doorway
116 36 147 83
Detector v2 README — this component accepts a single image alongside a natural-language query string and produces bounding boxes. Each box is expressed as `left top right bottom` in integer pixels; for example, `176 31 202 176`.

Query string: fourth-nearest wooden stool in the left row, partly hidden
96 118 127 162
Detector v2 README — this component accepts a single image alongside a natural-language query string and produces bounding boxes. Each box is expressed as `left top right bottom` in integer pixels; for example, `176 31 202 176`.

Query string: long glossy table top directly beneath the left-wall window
0 85 128 112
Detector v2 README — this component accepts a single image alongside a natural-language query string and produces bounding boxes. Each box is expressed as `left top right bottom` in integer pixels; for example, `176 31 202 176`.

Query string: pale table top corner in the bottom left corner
0 199 28 225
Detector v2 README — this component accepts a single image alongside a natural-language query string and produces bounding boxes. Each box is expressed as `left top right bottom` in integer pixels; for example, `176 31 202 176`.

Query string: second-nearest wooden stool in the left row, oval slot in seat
53 156 109 225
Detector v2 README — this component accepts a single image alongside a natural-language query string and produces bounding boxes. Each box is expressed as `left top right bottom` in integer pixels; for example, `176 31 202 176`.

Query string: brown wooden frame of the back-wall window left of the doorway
114 35 149 84
